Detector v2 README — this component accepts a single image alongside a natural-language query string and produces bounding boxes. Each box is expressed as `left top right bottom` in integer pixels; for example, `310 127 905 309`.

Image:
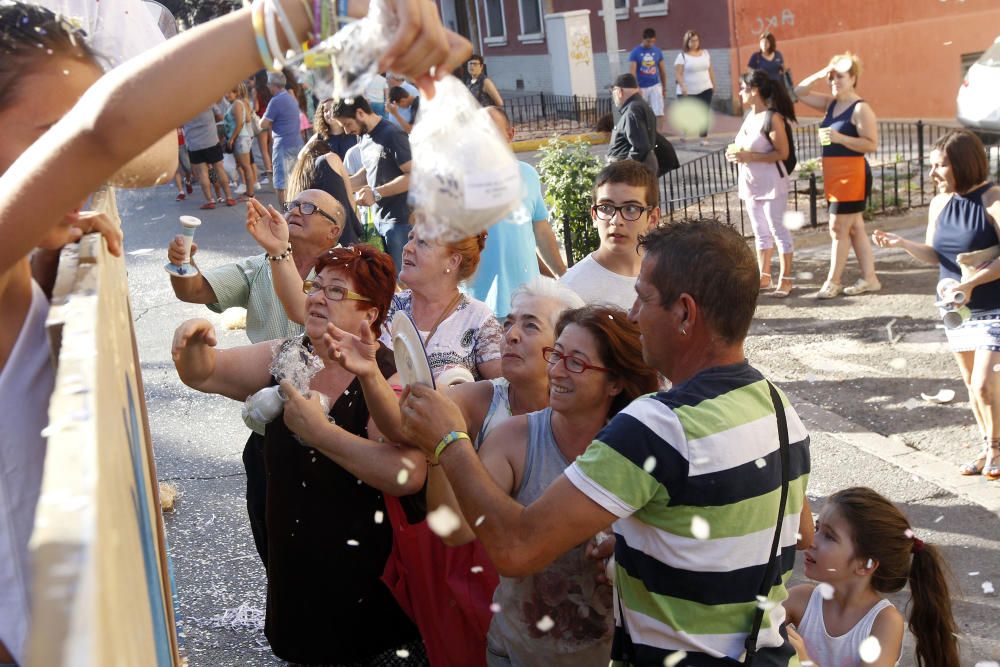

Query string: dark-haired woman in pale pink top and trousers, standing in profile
726 69 795 299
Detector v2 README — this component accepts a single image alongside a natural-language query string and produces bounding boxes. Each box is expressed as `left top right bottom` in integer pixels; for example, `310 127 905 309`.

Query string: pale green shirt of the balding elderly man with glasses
202 255 316 343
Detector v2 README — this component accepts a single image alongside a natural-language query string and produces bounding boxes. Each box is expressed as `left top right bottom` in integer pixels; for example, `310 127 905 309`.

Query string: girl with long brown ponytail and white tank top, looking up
784 487 959 667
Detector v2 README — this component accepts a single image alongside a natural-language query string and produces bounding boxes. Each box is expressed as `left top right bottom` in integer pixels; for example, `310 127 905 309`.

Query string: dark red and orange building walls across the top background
438 0 1000 118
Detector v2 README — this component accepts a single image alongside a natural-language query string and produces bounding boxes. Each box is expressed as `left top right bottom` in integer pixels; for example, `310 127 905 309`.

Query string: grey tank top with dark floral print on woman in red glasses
487 408 614 667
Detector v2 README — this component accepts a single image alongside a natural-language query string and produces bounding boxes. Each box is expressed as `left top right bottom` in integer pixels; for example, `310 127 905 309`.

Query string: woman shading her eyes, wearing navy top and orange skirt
795 52 882 299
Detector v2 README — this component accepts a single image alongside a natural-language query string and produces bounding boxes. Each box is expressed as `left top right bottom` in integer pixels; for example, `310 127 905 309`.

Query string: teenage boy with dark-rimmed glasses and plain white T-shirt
559 160 660 311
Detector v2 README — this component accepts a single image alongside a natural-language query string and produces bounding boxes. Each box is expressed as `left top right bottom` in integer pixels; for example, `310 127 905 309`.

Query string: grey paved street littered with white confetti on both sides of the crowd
119 179 1000 667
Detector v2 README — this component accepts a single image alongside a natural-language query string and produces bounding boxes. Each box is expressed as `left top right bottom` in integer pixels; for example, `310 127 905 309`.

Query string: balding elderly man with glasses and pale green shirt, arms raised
167 190 346 565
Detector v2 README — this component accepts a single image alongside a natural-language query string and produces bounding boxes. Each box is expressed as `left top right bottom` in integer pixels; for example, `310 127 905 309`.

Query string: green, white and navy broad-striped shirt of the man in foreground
566 362 809 666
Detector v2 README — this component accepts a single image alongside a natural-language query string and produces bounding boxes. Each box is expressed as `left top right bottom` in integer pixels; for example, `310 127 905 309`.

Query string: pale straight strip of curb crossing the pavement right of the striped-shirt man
788 394 1000 518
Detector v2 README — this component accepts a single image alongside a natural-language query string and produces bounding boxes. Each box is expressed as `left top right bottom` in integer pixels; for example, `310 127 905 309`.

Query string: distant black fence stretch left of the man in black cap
504 93 612 138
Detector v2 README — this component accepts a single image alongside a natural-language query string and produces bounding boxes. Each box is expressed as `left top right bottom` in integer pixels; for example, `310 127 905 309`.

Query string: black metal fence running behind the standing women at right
563 120 1000 264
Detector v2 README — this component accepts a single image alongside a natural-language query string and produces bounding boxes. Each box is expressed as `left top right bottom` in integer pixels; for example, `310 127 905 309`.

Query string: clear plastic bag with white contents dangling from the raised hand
408 76 522 240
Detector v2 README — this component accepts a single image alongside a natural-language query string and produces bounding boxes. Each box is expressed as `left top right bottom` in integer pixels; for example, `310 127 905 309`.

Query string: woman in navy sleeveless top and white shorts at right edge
872 130 1000 481
